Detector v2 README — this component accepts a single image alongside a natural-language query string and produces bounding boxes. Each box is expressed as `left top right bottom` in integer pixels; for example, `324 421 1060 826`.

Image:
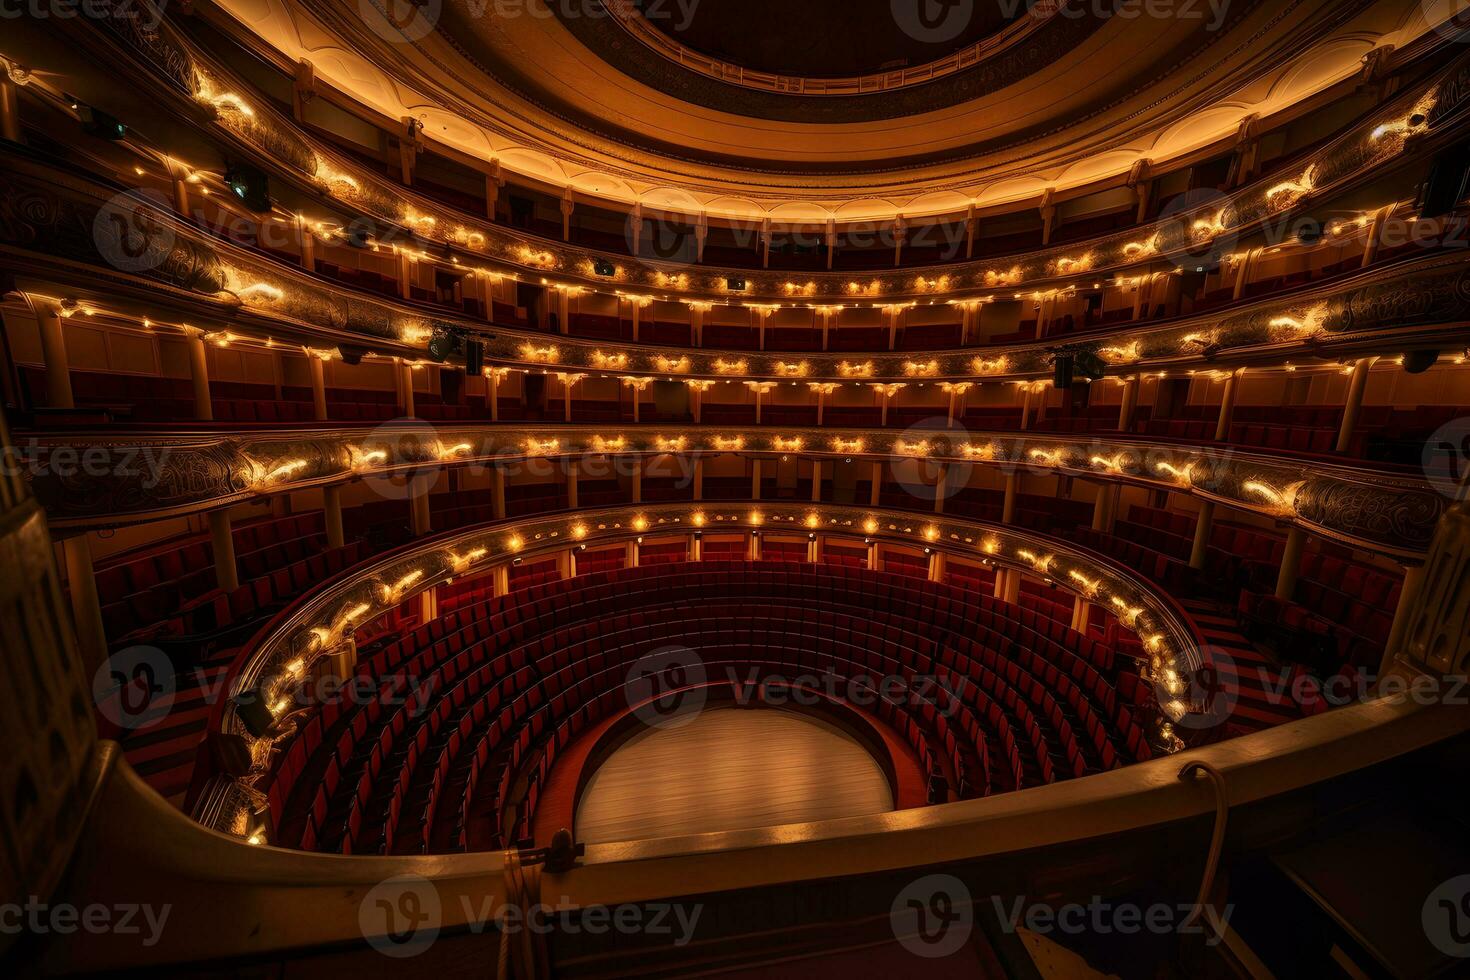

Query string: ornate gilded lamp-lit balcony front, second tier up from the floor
21 420 1451 563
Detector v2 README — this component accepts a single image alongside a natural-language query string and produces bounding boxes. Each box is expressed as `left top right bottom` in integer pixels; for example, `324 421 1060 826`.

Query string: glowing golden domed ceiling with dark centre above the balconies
212 0 1452 222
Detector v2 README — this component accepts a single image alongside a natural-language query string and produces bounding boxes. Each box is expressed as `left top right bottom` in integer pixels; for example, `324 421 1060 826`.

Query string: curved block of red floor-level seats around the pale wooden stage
270 563 1148 851
